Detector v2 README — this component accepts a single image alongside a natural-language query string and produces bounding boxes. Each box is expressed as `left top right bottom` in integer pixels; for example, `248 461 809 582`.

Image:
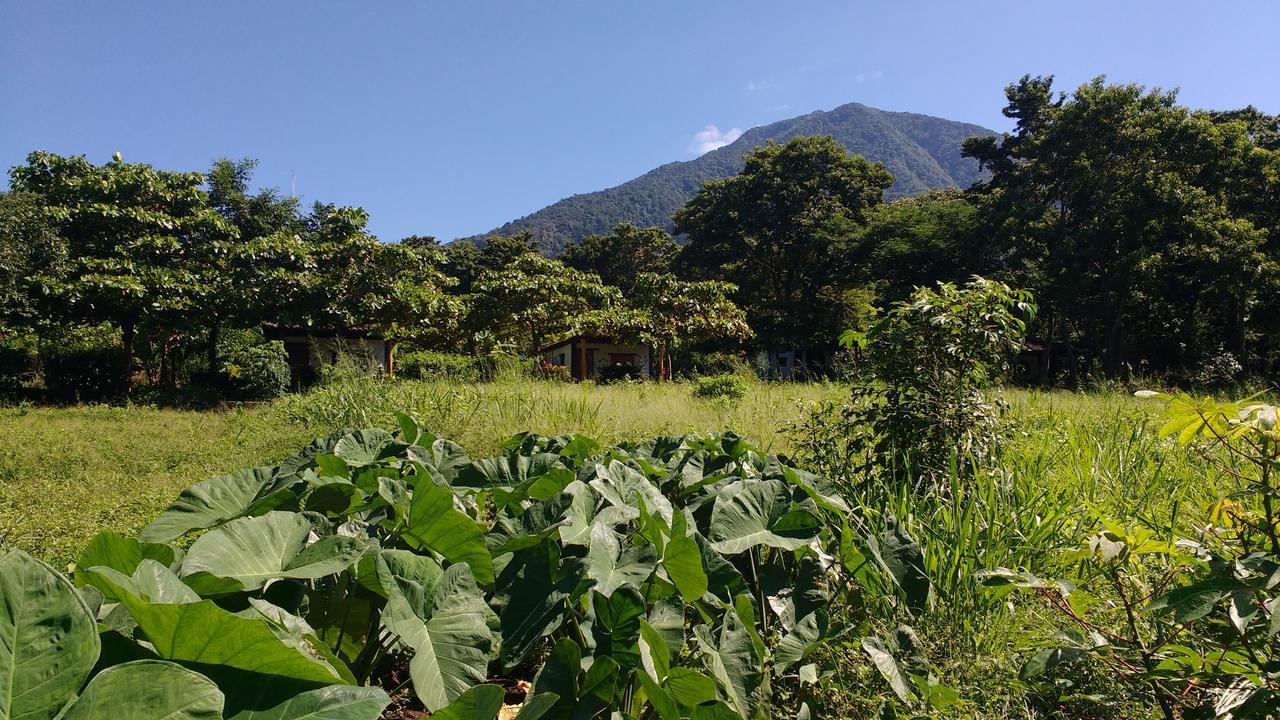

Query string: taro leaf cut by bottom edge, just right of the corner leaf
61 660 224 720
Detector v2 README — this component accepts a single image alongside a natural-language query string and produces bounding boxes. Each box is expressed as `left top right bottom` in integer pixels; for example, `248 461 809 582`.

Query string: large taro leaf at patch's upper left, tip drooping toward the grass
138 466 293 542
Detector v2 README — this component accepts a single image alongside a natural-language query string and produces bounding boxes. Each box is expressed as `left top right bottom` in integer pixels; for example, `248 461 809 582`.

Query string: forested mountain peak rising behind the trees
460 102 996 255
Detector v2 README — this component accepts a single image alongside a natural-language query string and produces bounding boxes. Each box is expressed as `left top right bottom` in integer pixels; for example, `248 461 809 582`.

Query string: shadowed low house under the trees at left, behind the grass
262 324 397 387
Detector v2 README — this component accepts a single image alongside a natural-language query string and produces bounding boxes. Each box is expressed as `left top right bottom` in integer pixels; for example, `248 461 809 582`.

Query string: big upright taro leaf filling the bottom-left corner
0 550 101 720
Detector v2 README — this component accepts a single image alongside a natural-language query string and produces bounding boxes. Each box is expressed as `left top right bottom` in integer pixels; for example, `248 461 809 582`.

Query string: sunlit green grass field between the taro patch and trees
0 371 1233 717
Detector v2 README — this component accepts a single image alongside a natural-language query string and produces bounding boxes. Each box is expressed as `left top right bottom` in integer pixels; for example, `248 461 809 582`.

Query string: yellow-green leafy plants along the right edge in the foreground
979 392 1280 720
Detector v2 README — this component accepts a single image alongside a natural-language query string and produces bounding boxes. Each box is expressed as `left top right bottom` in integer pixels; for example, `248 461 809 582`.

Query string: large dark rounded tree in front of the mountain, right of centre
675 137 893 347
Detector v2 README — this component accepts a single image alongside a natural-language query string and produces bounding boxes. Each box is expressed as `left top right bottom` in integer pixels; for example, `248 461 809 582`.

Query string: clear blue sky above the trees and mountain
0 0 1280 240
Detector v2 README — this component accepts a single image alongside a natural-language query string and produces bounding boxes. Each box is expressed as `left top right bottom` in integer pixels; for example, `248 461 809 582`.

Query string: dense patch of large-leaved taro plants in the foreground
0 416 851 720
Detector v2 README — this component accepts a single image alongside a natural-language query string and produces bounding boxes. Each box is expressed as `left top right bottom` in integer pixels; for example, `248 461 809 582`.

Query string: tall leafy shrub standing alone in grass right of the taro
801 277 1036 486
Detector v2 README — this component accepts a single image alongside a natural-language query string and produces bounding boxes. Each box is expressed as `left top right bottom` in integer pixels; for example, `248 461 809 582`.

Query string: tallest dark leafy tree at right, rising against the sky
964 76 1275 377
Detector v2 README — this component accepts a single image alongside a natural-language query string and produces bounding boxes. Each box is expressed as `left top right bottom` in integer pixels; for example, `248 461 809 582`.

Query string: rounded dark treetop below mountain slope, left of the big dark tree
559 223 680 293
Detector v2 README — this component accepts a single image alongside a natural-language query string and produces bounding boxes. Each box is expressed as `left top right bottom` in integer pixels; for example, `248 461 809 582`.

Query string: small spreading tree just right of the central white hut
627 273 751 379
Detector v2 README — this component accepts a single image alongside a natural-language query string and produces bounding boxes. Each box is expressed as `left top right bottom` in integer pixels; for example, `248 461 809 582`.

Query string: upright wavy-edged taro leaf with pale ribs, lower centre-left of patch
383 565 494 712
